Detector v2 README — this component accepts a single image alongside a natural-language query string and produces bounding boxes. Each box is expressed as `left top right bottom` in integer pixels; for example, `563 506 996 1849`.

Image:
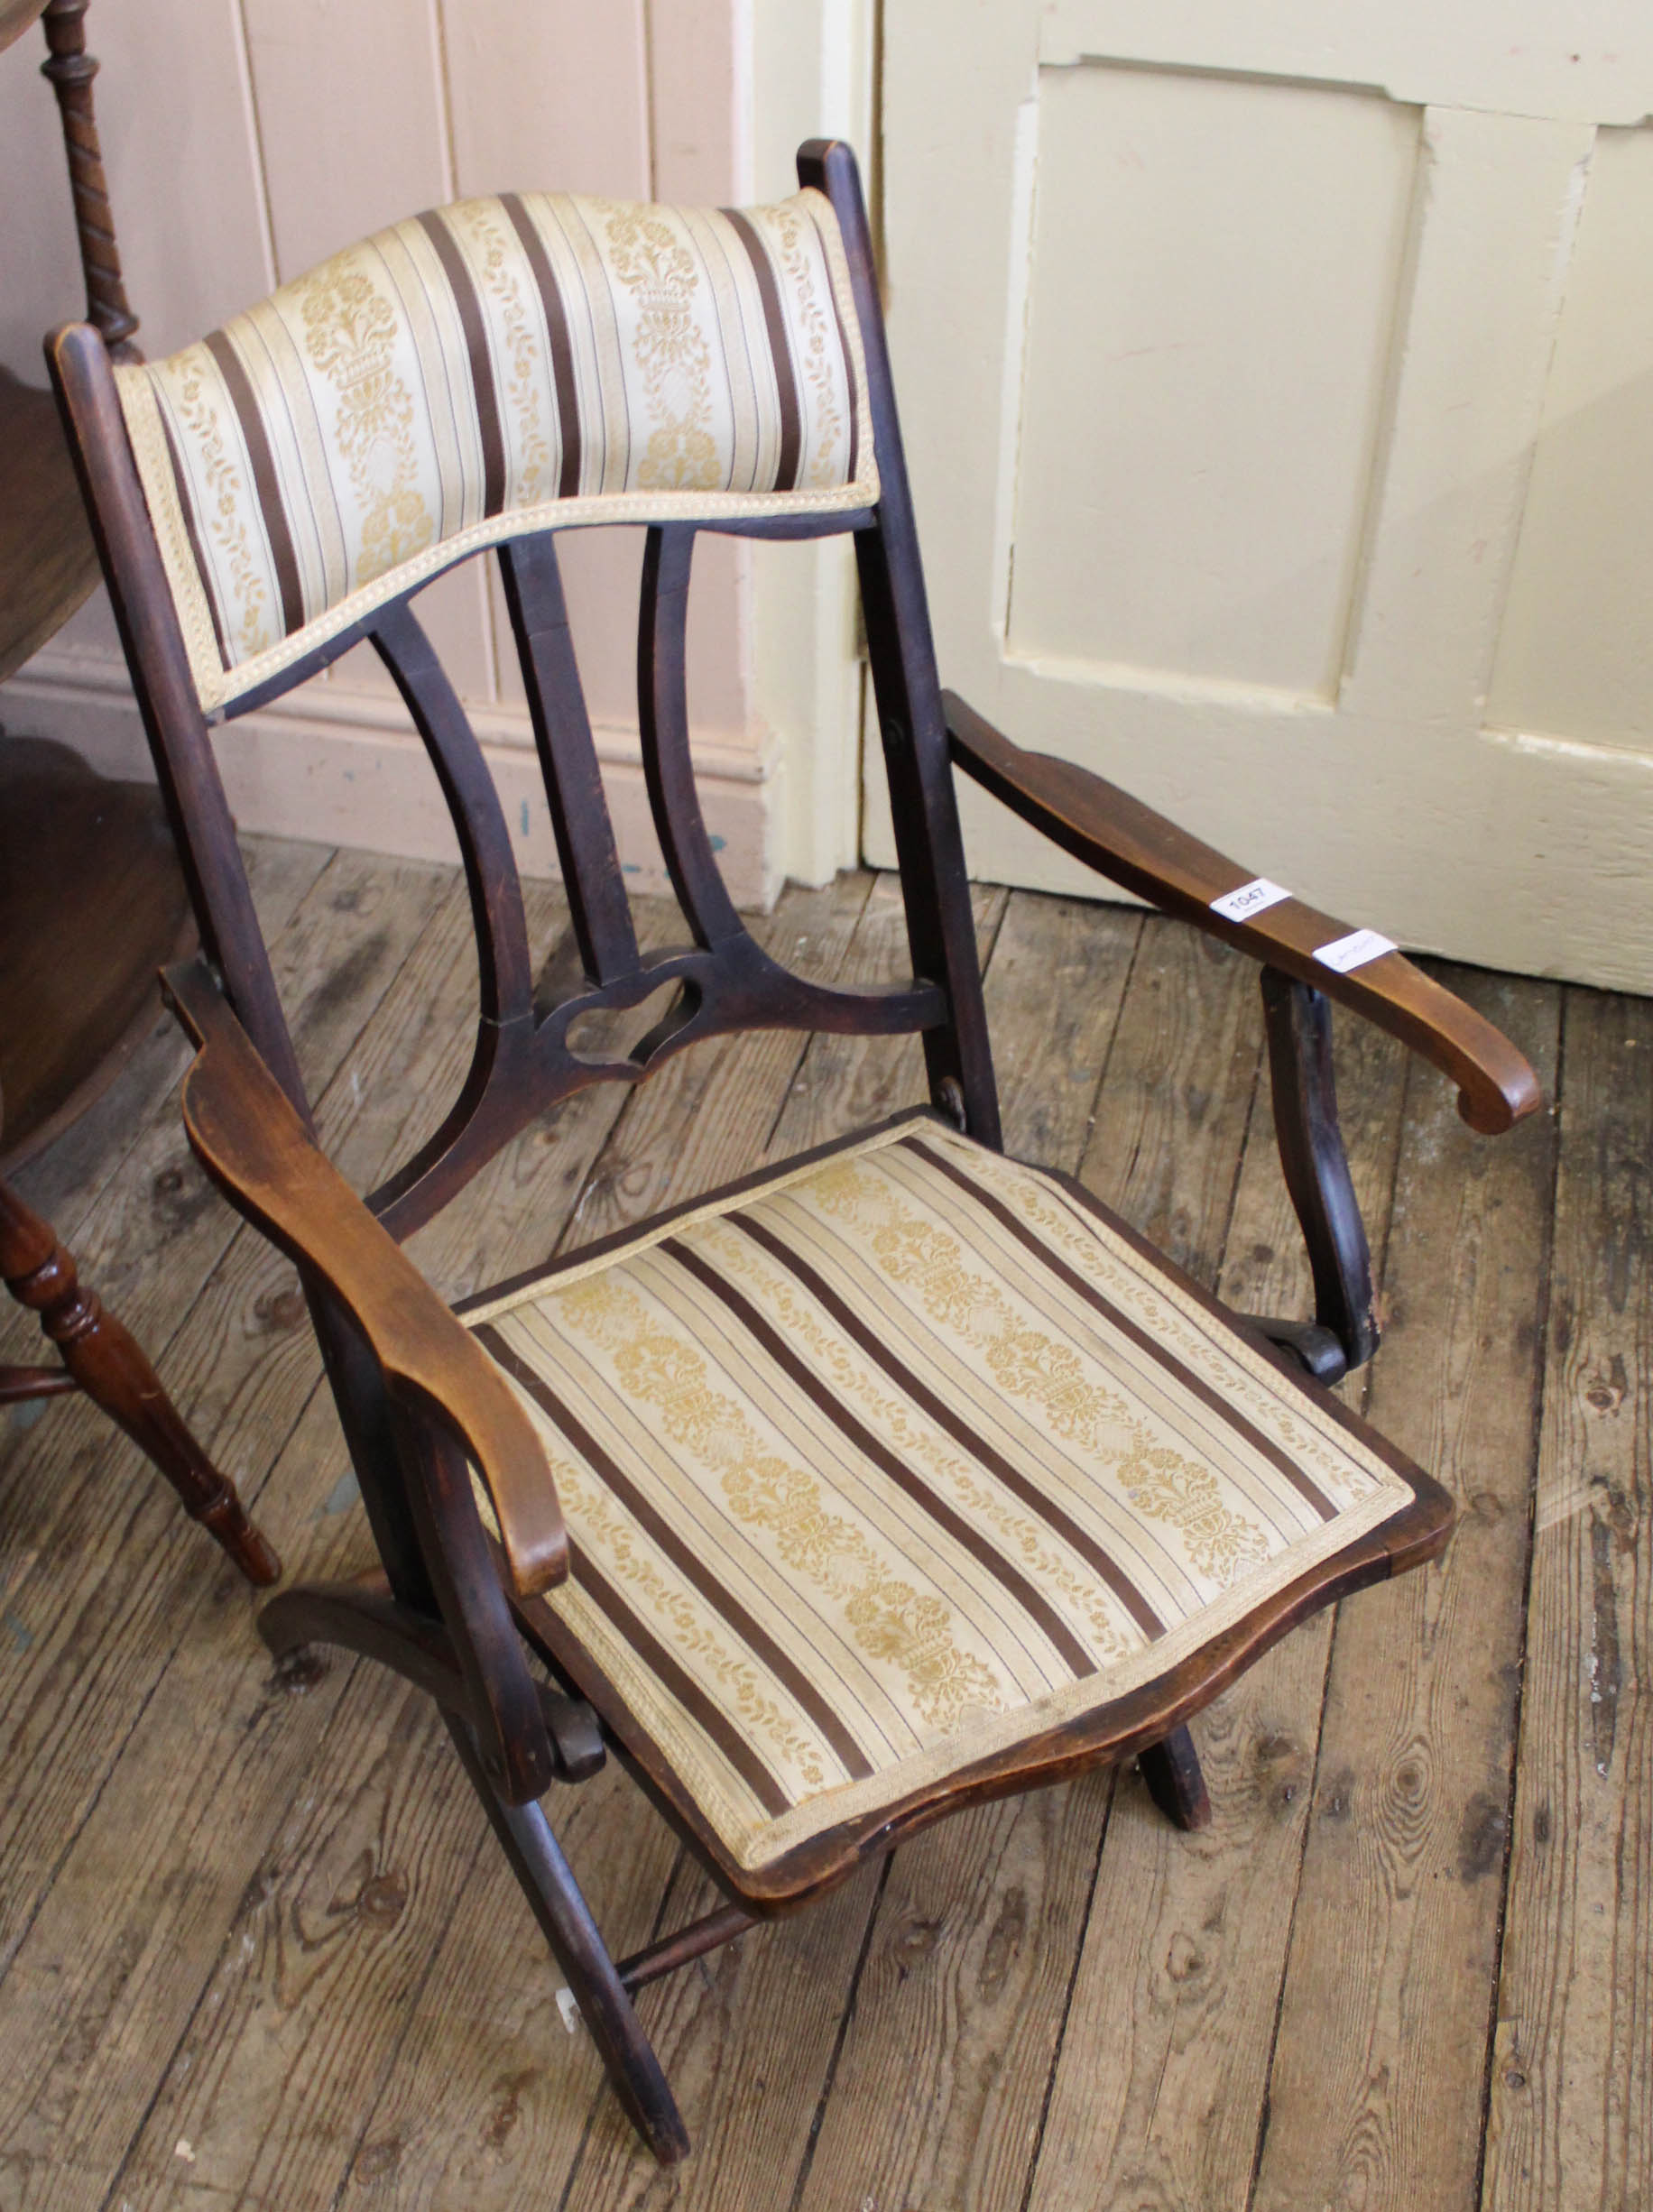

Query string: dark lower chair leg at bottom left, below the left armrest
442 1714 688 2166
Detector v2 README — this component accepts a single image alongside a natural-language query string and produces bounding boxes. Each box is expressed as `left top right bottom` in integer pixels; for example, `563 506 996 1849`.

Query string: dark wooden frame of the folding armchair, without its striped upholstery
49 142 1538 2161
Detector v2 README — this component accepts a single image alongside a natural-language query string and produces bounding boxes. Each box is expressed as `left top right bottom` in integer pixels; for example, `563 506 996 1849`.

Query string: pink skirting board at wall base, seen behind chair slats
0 646 786 911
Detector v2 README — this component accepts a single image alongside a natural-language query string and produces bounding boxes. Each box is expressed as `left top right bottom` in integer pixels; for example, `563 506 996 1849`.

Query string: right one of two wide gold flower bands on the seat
810 1159 1272 1586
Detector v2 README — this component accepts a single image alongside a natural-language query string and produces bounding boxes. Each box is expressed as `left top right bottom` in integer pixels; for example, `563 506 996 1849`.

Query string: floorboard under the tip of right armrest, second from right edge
1252 971 1560 2212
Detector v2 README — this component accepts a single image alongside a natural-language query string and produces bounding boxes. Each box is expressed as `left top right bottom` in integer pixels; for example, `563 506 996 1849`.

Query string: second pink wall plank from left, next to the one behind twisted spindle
244 0 494 699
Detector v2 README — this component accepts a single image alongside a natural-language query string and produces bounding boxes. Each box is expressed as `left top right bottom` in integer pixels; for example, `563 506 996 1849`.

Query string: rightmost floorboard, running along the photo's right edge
1482 991 1653 2212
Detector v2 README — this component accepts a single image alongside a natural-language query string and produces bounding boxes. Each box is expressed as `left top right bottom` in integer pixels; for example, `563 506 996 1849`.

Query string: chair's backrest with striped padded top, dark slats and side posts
47 142 998 1247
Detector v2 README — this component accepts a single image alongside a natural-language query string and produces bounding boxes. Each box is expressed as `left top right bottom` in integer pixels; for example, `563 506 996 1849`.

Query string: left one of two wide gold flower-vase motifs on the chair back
299 254 436 584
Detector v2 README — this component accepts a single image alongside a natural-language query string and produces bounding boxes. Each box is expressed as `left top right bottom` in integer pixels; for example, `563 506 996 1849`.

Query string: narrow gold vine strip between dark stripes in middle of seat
708 1230 1144 1659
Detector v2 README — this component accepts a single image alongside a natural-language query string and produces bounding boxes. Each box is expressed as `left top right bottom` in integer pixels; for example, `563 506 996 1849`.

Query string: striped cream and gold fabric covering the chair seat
465 1115 1412 1869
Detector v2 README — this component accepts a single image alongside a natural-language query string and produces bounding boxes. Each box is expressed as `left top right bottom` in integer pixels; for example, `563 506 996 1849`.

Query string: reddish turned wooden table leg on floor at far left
0 1184 281 1584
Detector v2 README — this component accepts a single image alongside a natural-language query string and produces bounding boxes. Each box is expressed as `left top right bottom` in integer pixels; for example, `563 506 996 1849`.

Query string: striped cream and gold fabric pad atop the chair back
117 192 879 710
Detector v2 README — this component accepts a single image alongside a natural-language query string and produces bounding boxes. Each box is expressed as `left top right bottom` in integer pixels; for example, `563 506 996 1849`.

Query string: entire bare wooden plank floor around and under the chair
0 841 1653 2212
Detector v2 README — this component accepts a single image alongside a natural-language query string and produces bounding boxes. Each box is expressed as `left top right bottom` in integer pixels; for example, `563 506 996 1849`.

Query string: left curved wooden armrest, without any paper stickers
162 960 568 1597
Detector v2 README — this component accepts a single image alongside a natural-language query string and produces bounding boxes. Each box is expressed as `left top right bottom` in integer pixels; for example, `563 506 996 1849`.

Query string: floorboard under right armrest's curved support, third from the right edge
1029 960 1405 2212
